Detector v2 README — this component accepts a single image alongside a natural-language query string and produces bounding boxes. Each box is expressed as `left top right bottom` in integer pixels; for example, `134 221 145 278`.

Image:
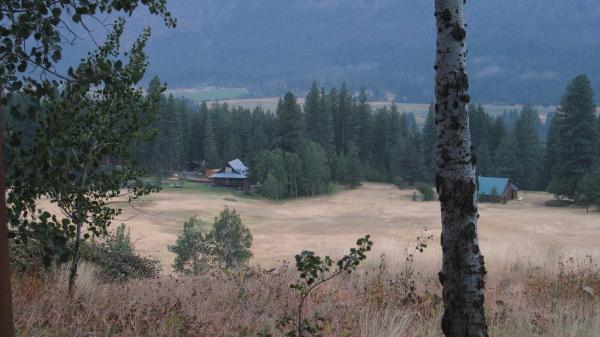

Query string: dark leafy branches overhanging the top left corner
0 0 176 96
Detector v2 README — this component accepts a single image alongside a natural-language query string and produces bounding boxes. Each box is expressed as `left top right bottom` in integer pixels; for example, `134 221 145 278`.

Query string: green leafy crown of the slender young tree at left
6 20 162 261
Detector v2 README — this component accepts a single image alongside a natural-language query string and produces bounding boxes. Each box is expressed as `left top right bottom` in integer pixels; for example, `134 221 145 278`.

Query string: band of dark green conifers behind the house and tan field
135 75 600 203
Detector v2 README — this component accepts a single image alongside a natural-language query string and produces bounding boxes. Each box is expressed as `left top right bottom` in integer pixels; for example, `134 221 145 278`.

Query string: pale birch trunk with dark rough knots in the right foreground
434 0 488 337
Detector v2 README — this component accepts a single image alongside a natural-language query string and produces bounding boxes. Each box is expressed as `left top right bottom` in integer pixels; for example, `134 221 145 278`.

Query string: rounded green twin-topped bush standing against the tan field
168 208 252 274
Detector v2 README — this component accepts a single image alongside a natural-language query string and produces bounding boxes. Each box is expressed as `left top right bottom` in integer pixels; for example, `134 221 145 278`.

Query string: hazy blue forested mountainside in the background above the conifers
109 0 600 104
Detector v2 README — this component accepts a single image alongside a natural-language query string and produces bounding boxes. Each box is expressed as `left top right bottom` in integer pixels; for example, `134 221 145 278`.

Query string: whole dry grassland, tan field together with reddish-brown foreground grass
15 184 600 337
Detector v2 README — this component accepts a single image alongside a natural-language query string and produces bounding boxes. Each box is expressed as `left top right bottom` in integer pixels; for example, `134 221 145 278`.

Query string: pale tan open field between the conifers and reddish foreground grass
122 183 600 272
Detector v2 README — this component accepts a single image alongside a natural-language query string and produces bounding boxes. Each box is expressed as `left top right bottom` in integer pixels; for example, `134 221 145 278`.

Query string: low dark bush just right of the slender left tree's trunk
81 224 160 282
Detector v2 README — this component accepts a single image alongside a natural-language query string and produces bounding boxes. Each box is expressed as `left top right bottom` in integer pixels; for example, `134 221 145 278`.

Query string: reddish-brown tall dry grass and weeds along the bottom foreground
14 255 600 337
